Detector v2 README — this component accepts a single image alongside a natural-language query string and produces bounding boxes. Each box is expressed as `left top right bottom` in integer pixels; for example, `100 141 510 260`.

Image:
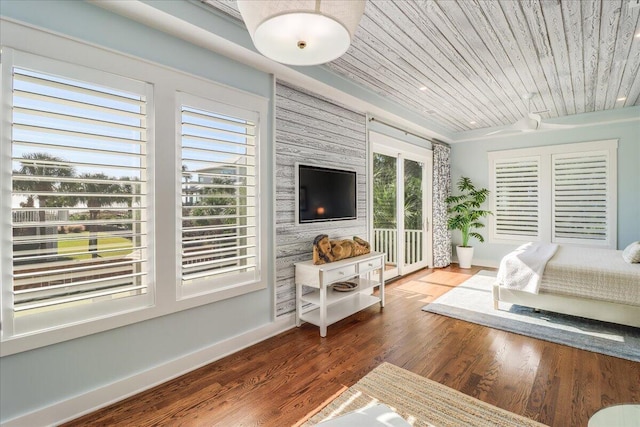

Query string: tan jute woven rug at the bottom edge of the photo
303 363 543 427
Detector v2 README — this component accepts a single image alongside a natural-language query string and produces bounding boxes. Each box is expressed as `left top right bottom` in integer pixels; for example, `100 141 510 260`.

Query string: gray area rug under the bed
422 270 640 362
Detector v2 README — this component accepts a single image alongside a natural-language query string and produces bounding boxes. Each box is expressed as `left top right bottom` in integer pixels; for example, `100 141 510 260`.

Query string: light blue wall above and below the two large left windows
0 0 274 422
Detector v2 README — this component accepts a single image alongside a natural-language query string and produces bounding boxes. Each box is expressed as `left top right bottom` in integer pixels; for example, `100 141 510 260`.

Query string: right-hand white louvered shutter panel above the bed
552 152 610 242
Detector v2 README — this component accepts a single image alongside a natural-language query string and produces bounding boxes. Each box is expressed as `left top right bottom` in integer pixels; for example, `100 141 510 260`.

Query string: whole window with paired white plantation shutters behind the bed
489 140 618 249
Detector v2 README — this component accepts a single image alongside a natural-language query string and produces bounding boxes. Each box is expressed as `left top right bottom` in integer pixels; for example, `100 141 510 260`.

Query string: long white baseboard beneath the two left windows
2 314 295 427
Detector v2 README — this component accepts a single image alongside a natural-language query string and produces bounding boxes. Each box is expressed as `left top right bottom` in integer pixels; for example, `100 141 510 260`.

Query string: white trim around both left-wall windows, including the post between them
0 41 274 356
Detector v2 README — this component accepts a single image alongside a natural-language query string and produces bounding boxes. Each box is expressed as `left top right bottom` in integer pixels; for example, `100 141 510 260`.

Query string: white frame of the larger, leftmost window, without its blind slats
1 48 155 339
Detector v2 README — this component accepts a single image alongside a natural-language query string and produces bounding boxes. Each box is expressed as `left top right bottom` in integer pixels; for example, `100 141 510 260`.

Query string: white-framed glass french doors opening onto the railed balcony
372 134 432 279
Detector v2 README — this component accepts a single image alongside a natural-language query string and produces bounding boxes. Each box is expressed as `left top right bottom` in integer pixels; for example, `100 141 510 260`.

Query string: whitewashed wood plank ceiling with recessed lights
202 0 640 133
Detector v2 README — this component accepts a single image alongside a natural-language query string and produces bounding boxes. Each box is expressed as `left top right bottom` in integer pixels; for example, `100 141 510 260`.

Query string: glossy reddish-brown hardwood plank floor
67 267 640 426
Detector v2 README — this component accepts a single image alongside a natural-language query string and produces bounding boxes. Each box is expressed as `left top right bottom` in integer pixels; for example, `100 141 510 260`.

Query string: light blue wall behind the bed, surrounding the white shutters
451 107 640 263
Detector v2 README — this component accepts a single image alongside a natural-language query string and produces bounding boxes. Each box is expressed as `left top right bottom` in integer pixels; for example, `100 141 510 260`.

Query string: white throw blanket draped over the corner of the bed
498 242 558 294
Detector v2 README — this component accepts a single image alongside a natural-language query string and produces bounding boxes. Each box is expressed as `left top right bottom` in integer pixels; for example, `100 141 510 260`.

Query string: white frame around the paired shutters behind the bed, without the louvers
488 139 618 249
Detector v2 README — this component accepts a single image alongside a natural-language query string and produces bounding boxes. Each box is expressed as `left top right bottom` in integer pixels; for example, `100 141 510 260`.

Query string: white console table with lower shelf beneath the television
295 252 385 337
